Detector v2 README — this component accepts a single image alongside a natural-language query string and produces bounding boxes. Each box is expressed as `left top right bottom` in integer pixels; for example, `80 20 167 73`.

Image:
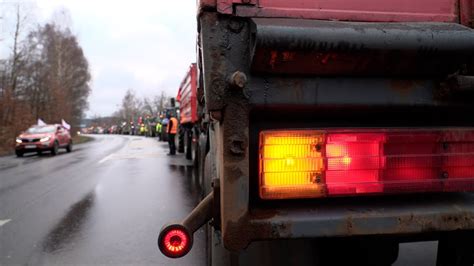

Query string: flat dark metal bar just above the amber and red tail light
246 76 440 107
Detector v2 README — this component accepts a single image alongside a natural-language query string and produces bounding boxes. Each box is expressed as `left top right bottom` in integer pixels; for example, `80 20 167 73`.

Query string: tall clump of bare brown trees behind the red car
0 4 91 154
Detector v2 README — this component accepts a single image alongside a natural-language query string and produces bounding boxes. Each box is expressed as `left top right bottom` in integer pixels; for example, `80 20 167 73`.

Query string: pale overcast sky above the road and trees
0 0 196 117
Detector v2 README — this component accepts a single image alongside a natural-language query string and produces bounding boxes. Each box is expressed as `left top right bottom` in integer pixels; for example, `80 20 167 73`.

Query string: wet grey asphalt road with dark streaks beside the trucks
0 135 436 266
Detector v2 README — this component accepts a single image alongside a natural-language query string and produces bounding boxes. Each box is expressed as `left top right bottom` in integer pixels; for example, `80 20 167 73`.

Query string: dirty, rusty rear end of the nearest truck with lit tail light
159 0 474 265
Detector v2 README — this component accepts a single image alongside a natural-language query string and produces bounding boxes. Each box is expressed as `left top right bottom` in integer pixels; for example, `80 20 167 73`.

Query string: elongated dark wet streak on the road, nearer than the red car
42 192 95 253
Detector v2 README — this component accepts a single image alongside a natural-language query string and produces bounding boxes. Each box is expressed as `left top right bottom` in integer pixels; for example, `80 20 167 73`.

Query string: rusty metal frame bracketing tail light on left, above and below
199 9 474 254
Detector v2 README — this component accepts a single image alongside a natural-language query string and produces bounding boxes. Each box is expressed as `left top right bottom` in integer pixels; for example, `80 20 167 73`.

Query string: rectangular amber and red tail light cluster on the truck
259 129 474 199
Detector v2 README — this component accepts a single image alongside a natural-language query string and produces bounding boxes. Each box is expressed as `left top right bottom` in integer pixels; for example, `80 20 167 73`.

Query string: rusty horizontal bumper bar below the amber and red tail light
224 193 474 250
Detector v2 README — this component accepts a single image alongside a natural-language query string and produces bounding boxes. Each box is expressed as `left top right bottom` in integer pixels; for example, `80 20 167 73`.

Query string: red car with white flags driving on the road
15 124 72 157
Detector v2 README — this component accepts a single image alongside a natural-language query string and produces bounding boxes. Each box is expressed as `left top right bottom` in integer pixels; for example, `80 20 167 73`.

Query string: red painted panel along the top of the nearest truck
231 0 459 22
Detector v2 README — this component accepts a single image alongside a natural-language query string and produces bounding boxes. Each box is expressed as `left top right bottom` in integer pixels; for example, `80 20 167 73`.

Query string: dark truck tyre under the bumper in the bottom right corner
436 231 474 266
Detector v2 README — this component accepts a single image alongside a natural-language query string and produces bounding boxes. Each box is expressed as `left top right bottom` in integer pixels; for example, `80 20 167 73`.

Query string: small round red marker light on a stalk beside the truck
158 224 193 258
